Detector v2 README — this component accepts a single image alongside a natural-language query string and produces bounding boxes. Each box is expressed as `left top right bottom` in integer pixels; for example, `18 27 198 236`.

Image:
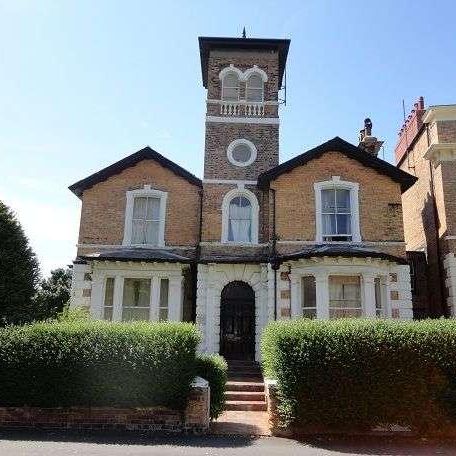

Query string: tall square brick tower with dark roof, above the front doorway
199 37 289 251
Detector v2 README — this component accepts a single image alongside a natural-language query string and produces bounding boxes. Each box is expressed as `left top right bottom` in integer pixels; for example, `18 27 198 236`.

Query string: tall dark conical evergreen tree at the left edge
0 201 40 326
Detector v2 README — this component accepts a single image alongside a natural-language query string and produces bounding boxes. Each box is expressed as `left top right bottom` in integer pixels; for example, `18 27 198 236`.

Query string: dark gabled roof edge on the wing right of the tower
258 136 417 192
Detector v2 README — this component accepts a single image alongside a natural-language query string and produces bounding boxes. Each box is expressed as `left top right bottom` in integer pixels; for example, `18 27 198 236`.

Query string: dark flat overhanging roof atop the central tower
198 36 290 88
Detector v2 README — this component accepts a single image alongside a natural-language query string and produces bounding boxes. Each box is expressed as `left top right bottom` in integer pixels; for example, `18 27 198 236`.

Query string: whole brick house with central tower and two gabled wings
70 38 415 359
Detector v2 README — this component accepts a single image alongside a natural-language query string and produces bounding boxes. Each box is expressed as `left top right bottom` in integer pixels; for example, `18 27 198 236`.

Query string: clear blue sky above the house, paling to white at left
0 0 456 274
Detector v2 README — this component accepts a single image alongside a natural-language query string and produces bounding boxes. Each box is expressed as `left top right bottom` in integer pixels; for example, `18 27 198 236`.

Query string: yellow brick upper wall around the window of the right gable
272 152 404 253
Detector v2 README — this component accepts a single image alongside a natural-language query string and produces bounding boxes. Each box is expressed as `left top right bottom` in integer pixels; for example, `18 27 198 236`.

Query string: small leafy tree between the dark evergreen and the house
34 268 71 320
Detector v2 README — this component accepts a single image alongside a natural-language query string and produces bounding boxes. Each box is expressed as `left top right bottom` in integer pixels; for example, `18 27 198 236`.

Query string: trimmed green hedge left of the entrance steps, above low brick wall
0 320 199 409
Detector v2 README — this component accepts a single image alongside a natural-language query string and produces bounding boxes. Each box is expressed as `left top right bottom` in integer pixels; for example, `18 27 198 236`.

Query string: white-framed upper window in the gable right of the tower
314 176 361 242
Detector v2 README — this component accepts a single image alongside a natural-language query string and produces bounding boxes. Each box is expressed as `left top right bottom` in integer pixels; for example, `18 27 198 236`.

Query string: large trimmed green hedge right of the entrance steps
262 319 456 431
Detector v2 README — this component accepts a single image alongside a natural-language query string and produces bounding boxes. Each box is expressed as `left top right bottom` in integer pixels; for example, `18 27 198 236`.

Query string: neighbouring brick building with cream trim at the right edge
395 97 456 318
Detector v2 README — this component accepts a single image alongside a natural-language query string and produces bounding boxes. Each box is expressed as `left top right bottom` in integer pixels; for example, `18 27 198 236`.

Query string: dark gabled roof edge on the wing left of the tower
68 146 202 196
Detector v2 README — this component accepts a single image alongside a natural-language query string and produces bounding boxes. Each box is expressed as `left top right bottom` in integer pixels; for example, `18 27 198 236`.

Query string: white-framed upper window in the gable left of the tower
123 185 167 247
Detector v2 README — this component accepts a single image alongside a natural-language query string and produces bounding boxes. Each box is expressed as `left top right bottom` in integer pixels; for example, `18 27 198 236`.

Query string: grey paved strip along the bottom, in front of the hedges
0 433 456 456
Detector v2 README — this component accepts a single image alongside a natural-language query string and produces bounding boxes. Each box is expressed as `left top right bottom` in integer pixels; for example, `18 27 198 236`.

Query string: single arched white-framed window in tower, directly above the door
222 189 259 244
